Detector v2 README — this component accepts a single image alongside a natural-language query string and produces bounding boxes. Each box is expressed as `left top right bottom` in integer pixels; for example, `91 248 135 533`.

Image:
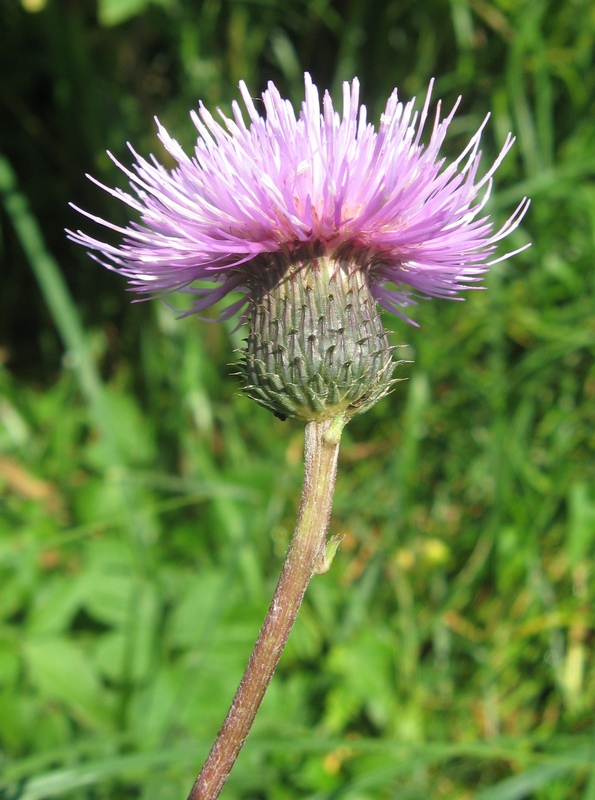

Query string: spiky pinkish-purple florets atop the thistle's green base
69 74 529 321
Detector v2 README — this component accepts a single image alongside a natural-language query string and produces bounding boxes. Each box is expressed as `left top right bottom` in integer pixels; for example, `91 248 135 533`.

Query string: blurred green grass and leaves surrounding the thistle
0 0 595 800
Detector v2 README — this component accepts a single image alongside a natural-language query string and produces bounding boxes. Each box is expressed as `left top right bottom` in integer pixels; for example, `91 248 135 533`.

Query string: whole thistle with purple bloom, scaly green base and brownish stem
69 74 529 800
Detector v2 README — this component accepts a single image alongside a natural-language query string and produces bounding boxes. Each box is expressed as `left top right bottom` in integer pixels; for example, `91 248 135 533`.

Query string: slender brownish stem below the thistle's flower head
188 414 347 800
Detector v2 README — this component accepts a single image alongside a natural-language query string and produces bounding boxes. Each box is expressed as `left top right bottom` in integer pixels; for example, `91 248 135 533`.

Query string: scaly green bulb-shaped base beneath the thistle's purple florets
241 254 396 422
